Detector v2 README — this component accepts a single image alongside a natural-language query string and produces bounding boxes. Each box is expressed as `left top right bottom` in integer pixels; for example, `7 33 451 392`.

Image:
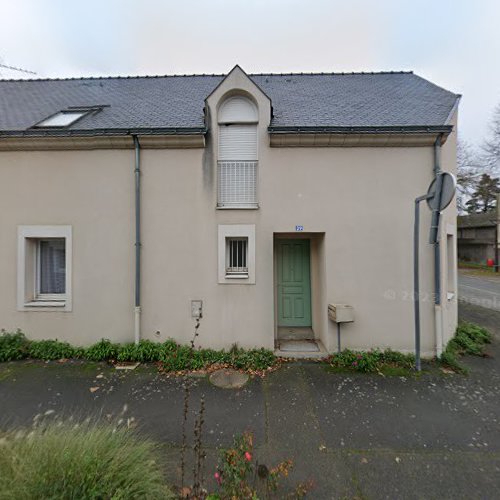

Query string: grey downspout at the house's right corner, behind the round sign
430 134 443 358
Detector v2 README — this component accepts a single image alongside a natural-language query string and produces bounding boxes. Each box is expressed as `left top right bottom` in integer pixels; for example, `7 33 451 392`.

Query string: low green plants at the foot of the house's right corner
440 322 493 374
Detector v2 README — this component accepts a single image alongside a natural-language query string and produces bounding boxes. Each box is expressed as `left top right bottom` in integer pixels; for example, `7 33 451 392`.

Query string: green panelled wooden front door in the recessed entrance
277 240 311 327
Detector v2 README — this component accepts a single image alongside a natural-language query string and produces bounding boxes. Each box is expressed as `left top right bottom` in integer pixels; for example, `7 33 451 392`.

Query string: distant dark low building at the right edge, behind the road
457 196 500 266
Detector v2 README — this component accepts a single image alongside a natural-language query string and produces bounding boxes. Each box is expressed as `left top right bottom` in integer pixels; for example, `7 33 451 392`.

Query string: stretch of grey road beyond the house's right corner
458 271 500 311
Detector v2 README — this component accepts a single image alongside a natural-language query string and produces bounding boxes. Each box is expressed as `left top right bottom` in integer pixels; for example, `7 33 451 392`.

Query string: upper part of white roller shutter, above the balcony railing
219 124 257 161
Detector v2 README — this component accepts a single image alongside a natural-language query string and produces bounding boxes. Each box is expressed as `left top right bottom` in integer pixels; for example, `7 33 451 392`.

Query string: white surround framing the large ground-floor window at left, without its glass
17 226 73 311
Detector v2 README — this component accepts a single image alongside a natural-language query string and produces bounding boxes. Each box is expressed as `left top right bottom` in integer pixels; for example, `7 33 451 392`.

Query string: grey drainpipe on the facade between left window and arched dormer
132 135 141 344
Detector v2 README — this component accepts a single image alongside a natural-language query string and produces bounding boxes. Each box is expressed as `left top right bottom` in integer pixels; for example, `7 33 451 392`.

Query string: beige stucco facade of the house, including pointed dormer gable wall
0 67 457 356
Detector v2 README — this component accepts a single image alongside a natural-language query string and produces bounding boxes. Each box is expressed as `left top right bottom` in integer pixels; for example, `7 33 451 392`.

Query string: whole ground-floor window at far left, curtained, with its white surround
17 226 72 311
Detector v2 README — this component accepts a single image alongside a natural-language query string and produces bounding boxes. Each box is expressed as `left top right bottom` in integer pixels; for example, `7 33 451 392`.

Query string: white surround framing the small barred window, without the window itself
218 224 255 285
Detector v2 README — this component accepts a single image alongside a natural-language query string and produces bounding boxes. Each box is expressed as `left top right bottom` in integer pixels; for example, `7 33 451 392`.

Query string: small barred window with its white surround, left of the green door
218 224 255 284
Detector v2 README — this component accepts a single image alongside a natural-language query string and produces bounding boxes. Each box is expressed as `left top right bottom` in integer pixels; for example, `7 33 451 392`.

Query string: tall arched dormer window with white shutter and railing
217 96 259 208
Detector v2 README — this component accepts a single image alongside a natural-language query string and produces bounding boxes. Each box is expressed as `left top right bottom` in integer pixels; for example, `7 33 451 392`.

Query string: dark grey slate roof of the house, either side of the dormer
0 72 459 134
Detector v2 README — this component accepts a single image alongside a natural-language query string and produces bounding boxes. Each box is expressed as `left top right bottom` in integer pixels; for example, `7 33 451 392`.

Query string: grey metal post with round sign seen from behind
413 172 457 371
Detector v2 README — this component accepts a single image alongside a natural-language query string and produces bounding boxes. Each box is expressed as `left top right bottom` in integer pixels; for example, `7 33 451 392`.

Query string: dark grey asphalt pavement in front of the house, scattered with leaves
0 304 500 499
